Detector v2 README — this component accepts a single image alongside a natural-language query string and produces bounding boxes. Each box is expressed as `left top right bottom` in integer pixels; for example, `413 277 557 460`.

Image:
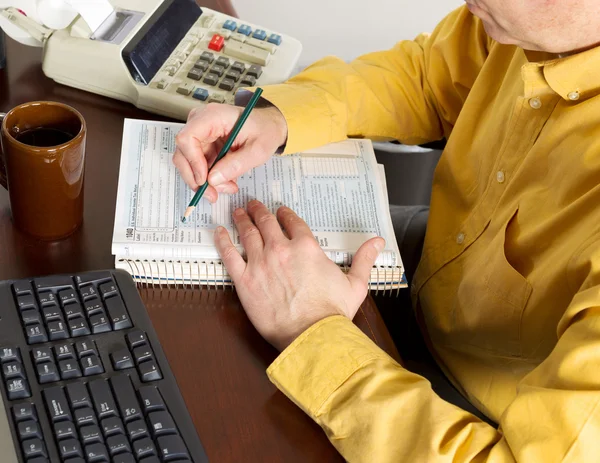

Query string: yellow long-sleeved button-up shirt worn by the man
264 8 600 463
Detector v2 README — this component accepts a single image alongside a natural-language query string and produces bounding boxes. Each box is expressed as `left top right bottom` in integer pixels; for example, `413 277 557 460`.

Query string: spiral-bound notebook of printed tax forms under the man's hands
112 119 406 292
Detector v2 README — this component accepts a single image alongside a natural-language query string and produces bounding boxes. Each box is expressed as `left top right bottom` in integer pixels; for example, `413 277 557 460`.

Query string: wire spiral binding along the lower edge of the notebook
118 259 405 297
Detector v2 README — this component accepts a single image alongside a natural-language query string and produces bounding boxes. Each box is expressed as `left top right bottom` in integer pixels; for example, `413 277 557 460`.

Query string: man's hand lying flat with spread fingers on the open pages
215 201 385 350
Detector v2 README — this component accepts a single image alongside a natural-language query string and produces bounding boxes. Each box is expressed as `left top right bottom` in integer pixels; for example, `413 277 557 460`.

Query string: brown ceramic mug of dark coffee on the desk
0 101 87 240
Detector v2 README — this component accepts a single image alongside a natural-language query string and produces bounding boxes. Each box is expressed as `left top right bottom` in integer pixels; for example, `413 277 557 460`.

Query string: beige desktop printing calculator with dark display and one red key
0 0 302 120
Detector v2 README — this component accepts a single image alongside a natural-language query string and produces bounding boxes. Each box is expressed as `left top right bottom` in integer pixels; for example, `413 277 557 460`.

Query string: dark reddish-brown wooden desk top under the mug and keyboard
0 35 398 463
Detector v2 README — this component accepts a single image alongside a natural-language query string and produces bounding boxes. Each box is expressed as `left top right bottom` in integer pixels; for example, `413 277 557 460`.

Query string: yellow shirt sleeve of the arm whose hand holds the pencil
263 7 491 153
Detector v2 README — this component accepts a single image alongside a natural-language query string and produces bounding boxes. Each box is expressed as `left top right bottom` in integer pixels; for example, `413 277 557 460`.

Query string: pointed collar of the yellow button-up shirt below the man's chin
525 46 600 101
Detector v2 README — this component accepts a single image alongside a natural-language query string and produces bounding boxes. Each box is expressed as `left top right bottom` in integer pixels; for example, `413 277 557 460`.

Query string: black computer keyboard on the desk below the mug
0 270 208 463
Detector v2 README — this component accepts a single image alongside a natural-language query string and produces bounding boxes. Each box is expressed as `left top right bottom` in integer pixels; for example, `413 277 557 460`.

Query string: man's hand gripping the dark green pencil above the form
173 103 287 202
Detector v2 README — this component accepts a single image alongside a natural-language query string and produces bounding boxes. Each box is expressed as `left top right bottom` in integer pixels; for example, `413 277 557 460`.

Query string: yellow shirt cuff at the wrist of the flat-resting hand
267 315 393 419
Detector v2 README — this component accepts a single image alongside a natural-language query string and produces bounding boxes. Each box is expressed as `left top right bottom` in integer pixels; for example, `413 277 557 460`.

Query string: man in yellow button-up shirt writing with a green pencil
174 0 600 462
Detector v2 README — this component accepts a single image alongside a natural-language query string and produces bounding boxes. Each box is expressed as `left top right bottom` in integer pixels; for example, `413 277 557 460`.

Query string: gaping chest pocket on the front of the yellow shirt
453 209 532 356
